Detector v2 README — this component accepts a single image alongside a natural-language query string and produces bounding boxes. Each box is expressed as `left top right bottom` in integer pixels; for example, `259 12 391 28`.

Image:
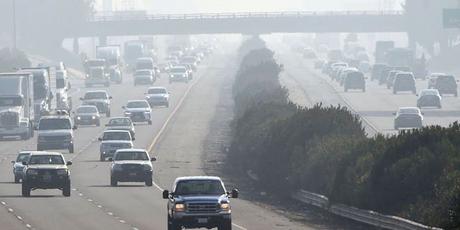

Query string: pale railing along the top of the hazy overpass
91 11 404 21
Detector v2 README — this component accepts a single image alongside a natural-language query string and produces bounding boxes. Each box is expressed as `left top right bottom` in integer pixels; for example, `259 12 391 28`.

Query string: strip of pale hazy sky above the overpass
96 0 404 13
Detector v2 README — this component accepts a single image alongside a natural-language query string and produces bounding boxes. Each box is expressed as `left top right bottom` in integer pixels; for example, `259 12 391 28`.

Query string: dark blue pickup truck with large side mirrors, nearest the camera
163 176 238 230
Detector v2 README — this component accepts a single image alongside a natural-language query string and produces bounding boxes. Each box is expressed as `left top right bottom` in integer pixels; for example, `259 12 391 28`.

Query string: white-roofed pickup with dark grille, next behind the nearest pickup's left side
110 149 156 186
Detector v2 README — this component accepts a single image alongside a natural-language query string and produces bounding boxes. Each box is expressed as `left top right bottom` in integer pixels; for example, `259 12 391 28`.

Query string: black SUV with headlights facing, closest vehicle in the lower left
22 152 72 197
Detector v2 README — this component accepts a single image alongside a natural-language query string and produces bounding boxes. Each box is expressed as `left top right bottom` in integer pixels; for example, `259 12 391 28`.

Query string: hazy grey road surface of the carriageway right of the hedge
267 39 460 136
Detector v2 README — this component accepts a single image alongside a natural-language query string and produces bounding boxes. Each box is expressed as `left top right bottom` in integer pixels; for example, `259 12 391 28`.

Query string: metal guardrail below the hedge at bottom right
292 190 442 230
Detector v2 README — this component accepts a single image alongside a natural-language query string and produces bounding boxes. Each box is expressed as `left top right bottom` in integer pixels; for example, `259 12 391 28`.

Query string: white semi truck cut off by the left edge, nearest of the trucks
0 72 35 140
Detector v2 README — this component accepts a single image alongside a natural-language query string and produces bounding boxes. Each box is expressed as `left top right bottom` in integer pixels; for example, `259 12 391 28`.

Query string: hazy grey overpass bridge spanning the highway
73 11 408 38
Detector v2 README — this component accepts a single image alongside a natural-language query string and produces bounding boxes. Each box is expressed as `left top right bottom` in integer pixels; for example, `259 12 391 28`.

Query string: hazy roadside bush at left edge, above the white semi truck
0 48 31 72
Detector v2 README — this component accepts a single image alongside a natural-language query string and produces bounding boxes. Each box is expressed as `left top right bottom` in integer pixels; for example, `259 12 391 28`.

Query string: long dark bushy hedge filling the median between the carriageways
229 38 460 229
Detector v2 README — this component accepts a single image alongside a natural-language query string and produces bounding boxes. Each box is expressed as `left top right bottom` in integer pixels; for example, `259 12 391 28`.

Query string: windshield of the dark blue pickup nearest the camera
174 180 225 196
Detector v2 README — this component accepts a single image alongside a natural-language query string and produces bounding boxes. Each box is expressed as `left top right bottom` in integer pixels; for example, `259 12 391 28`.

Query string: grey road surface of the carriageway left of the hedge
0 44 324 230
